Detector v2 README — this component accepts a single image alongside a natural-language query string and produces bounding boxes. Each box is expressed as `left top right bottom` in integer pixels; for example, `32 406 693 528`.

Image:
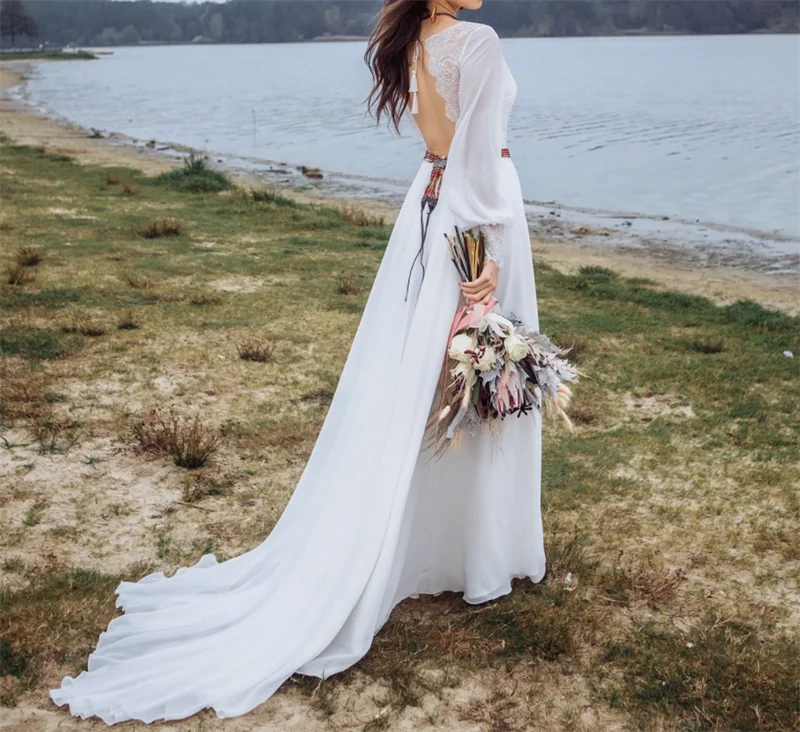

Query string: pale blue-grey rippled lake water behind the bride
17 35 800 247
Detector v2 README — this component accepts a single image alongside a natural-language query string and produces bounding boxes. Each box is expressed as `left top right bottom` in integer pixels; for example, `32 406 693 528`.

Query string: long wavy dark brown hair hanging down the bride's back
364 0 428 132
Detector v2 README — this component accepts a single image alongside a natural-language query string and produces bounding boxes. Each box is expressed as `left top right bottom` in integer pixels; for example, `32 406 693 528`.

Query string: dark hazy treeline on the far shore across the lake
0 0 800 47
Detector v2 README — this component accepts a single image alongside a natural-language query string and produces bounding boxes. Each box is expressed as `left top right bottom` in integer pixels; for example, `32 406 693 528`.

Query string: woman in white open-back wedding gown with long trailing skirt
50 0 545 724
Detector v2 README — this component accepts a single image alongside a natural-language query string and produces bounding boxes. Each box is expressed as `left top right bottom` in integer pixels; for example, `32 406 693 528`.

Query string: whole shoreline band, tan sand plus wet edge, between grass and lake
0 62 800 315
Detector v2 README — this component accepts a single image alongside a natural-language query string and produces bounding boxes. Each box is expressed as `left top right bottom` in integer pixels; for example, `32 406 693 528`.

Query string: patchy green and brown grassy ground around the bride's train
0 134 800 732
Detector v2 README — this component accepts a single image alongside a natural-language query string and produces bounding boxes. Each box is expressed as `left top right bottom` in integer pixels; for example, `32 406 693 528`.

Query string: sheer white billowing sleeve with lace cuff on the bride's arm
446 25 514 266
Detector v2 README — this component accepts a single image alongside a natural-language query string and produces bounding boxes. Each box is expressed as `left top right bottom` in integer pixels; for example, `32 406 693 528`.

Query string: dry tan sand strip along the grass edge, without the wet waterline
0 58 800 314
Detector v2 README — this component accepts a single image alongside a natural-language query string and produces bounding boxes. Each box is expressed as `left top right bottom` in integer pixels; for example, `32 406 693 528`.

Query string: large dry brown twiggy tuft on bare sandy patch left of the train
133 407 221 470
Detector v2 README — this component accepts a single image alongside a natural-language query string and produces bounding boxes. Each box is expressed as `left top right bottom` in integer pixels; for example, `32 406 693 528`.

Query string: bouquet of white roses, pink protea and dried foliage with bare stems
430 228 580 454
